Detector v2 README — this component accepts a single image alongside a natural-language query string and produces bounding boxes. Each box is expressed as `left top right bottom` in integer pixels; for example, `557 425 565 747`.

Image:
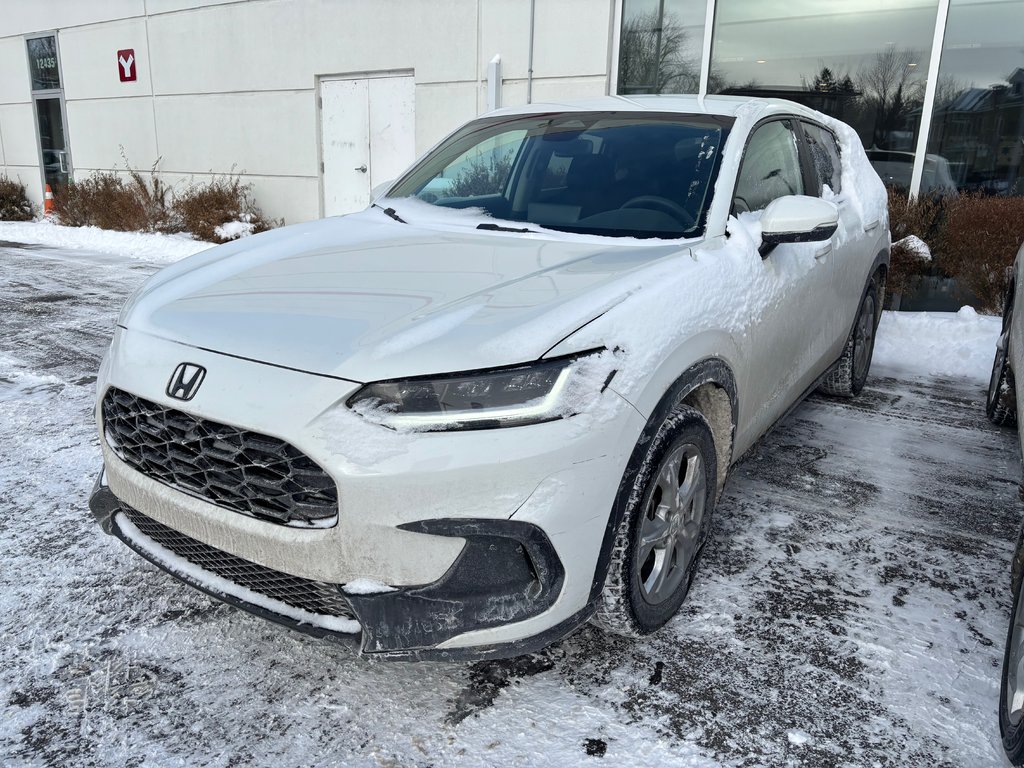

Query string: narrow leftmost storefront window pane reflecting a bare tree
618 0 708 94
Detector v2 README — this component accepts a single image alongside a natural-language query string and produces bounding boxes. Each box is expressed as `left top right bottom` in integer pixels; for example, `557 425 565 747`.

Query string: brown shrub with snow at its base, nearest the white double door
171 175 282 243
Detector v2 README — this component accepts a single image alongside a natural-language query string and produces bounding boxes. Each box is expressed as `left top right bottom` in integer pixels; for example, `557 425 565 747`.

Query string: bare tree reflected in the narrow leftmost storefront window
618 9 700 93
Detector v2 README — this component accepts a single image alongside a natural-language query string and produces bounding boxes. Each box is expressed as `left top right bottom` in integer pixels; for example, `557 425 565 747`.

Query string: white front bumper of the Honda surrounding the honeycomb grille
91 330 645 658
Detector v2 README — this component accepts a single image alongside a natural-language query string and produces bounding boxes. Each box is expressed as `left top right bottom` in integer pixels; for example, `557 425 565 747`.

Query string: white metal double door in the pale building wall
321 76 416 216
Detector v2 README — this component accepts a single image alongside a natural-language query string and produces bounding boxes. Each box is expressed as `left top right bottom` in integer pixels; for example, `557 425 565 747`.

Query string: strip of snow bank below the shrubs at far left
0 219 214 262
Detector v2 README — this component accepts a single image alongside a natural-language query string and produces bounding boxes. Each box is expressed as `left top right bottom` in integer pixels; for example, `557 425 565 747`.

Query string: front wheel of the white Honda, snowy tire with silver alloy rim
592 406 718 637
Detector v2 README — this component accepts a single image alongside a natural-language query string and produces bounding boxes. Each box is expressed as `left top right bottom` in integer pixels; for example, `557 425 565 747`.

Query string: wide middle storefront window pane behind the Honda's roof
708 0 938 177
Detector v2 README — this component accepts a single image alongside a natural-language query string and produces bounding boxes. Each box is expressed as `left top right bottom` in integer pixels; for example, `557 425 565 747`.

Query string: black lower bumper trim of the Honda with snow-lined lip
95 473 591 660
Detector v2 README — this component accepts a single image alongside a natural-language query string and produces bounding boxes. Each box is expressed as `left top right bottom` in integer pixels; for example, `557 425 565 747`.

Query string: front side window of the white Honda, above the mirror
732 120 804 213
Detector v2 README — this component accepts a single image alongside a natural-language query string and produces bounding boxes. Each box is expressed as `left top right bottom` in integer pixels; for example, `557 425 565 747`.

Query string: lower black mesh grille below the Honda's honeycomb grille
121 506 354 618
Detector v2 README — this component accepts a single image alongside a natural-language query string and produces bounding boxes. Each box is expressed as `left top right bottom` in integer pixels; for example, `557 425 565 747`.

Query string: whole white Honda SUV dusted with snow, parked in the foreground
90 96 890 659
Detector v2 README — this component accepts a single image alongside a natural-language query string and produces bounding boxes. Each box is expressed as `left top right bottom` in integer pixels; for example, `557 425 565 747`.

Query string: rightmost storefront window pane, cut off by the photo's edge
921 0 1024 196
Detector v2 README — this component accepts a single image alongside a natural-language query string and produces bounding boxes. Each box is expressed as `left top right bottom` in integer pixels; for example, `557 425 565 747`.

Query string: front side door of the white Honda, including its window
733 118 833 442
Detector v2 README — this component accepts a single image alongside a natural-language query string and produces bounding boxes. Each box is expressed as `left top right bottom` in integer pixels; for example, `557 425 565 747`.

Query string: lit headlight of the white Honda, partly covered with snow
346 355 604 431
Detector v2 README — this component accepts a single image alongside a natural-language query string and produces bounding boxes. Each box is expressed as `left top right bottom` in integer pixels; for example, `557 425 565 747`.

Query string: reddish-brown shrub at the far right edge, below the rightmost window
937 195 1024 313
